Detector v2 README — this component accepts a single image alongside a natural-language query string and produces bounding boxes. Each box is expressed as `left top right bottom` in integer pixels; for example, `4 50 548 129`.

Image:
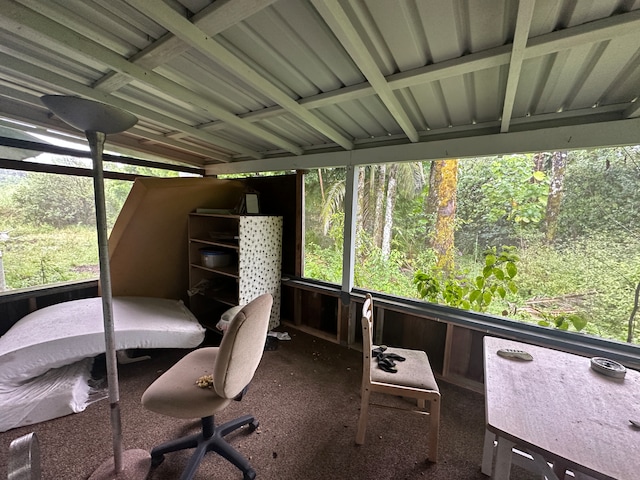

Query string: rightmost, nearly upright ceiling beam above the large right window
500 0 536 133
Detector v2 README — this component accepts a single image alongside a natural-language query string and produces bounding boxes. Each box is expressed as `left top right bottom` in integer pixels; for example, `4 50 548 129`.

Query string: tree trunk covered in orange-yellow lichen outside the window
425 159 458 274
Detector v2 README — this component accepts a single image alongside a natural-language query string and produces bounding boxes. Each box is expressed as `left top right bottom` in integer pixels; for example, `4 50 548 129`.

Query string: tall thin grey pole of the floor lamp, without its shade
85 131 123 474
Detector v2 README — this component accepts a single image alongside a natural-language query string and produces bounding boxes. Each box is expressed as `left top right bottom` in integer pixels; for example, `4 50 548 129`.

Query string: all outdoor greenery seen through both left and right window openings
0 147 640 343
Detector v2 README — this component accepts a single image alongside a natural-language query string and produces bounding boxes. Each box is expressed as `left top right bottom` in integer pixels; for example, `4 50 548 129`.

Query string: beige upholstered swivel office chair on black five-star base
142 294 273 480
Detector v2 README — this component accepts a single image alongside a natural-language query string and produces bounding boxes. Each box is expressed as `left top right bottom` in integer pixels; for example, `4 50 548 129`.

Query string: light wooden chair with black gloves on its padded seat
356 294 440 462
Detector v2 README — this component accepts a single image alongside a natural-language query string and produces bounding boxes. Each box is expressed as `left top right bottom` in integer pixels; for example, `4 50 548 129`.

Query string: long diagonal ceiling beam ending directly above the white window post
126 0 353 150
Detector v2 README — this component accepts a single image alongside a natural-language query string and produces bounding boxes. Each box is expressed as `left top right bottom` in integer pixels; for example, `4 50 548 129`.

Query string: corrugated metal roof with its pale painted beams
0 0 640 171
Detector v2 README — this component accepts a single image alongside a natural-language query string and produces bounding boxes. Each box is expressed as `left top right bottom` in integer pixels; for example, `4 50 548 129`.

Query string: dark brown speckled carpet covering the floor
0 330 535 480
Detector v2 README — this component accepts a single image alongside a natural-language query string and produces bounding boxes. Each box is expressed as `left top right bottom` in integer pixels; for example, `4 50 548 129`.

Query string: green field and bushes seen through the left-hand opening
0 157 175 291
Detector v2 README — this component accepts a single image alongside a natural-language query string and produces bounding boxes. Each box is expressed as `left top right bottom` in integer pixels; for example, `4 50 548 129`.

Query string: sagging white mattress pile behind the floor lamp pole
0 297 205 431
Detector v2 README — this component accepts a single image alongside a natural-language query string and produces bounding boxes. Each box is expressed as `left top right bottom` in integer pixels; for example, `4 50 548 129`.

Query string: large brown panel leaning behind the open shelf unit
109 177 245 301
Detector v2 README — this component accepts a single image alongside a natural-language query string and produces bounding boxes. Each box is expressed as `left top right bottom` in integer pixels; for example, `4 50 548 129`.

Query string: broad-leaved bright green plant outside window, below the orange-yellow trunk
413 246 519 312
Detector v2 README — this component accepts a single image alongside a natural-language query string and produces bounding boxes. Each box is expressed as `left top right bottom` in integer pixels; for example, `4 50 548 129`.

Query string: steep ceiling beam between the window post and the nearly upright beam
312 0 420 142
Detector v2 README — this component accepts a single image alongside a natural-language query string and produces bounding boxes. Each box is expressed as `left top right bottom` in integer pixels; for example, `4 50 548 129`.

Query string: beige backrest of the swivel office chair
213 293 273 398
